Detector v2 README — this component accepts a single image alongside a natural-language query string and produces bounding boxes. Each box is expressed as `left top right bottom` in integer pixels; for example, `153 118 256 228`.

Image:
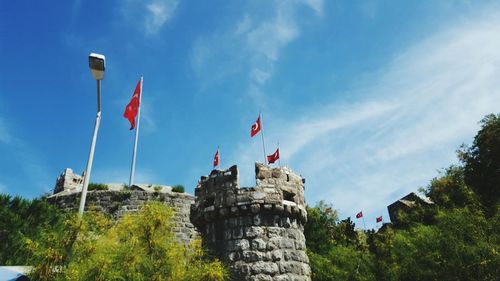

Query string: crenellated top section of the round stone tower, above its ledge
191 163 307 223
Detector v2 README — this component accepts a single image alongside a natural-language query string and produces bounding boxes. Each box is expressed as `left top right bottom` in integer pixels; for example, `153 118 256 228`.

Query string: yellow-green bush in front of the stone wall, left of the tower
28 203 227 281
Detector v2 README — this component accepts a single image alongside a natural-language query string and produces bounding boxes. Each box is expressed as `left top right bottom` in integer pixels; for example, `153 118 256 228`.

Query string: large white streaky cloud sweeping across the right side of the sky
232 10 500 228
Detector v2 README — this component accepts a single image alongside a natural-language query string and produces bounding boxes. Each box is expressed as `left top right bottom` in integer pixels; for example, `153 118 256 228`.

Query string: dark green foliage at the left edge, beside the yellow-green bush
0 194 62 265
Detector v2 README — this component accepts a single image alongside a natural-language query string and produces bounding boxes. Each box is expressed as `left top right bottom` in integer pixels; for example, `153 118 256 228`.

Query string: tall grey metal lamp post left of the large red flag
78 53 106 216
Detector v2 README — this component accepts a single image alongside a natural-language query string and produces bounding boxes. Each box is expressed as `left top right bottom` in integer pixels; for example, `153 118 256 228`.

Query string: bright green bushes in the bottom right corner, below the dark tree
373 208 500 281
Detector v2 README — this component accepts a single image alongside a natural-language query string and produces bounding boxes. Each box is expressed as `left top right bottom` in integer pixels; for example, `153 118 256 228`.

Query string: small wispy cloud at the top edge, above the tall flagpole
122 0 179 36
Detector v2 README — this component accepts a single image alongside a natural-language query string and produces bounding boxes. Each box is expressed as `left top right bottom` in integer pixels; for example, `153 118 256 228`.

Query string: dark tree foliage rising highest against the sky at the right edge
459 114 500 216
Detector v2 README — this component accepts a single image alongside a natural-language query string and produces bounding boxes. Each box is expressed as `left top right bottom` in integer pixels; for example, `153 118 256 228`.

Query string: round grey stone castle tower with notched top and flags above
191 163 311 281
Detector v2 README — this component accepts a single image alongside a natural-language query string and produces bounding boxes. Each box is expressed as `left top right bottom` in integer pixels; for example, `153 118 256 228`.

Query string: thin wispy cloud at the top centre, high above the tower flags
191 0 323 96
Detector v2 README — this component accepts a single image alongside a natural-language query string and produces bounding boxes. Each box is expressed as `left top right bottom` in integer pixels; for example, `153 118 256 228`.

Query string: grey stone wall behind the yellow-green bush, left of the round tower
47 190 198 243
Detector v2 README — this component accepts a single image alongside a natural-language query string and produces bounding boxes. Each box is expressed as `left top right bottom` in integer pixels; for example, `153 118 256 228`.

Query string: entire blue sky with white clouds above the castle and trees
0 0 500 226
